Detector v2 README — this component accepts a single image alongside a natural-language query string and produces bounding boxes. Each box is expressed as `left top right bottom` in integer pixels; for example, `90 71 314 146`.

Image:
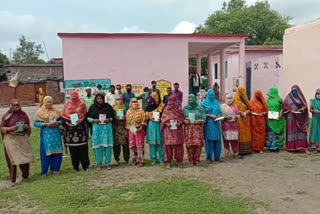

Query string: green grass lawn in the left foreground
0 130 254 214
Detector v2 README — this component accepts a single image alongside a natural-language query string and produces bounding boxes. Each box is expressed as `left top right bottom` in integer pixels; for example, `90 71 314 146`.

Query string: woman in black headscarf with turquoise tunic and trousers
87 94 115 171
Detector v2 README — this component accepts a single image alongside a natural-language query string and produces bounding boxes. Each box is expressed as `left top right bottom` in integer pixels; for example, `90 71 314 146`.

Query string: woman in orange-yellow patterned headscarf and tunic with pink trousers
126 98 147 167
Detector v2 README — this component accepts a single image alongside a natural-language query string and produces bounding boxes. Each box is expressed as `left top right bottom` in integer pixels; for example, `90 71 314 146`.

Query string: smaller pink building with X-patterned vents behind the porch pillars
211 45 282 98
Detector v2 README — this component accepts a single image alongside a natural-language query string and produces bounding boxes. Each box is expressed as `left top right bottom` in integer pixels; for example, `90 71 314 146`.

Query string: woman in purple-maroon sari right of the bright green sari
283 85 310 154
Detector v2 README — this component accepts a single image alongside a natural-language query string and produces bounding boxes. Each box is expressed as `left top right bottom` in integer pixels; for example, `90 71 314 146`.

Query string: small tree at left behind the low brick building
13 36 45 64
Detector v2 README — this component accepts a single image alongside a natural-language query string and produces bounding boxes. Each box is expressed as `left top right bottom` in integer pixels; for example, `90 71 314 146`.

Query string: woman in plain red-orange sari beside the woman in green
250 90 268 153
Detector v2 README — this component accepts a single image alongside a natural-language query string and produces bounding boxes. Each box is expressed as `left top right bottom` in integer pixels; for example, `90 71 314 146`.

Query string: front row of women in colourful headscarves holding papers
1 86 320 186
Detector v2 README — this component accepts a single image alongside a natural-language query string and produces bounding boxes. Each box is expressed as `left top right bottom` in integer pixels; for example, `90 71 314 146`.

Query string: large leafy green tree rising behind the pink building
195 0 291 45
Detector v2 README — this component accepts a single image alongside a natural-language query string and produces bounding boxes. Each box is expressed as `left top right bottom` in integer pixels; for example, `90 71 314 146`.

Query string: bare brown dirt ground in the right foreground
90 151 320 214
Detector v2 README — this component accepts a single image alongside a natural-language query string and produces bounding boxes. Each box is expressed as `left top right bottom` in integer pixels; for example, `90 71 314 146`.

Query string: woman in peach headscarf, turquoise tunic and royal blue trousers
34 96 63 176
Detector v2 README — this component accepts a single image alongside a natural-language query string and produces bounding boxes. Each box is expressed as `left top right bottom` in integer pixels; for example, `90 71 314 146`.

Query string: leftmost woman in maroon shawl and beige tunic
1 99 33 185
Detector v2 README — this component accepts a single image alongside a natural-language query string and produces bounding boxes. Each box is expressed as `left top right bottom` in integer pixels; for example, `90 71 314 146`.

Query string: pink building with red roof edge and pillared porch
58 33 248 103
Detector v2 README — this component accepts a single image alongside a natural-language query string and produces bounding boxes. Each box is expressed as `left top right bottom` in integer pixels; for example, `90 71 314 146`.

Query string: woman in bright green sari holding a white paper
266 88 285 151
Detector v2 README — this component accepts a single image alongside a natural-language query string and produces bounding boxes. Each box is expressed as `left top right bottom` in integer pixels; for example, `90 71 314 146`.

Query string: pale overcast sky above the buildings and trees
0 0 320 59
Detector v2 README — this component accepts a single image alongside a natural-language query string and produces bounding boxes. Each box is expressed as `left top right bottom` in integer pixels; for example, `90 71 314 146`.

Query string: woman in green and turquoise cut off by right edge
309 89 320 152
